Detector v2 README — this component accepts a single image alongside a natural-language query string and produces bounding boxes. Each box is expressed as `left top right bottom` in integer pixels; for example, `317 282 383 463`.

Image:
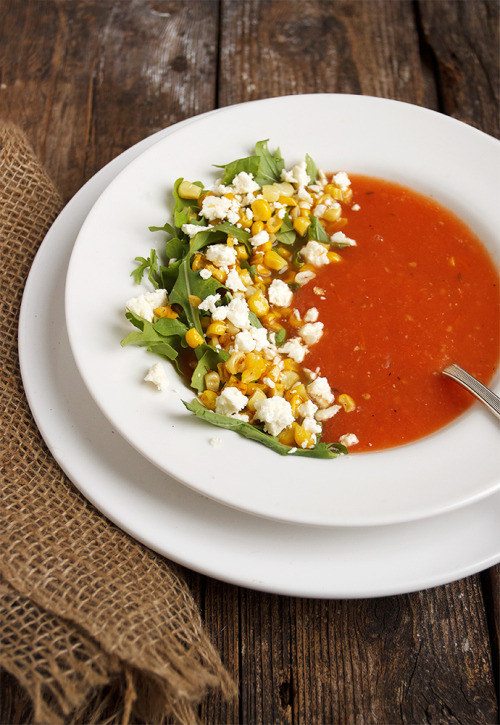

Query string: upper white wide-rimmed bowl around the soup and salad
66 95 500 526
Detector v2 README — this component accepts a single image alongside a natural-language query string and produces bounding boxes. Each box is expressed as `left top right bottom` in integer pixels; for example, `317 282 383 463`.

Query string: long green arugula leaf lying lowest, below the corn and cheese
182 398 347 458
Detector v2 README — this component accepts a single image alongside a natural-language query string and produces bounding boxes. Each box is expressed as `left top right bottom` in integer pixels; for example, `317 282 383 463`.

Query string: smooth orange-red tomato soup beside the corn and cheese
295 175 500 453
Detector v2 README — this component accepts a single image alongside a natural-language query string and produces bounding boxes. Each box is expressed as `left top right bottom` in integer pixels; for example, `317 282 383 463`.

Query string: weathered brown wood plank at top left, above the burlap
0 0 218 198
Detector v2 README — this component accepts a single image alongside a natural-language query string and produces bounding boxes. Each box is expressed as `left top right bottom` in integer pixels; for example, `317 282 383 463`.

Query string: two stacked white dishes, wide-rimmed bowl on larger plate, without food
19 95 500 598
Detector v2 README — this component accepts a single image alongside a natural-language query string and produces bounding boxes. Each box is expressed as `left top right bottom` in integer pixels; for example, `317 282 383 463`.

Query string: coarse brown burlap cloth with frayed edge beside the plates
0 122 234 723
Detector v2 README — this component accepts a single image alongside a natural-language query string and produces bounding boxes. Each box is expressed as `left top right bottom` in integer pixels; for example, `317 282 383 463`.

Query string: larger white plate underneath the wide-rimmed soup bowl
19 113 500 598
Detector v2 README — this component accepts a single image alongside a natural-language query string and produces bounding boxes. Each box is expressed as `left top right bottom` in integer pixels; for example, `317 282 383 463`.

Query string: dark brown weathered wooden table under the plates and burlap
0 0 500 723
